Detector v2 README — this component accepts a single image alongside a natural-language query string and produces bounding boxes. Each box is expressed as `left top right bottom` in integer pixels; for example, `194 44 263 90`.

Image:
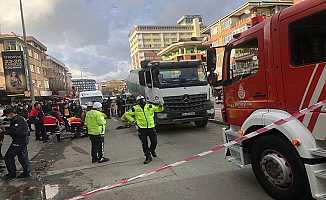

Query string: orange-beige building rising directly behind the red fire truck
202 0 293 79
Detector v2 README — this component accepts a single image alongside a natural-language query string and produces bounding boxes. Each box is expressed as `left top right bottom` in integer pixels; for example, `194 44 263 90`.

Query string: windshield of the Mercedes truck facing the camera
158 66 207 87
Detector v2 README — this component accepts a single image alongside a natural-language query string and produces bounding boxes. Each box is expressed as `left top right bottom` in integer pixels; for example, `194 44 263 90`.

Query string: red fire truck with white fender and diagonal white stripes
207 0 326 200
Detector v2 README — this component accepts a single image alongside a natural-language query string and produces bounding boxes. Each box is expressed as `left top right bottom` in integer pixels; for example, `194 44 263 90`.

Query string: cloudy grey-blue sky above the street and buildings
0 0 244 81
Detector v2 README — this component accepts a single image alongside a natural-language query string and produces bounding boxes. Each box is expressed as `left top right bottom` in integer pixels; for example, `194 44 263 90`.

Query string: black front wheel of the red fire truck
251 135 311 200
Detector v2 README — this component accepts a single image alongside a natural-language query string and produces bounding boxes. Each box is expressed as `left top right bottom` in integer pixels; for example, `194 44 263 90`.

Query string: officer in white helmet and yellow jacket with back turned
85 102 110 163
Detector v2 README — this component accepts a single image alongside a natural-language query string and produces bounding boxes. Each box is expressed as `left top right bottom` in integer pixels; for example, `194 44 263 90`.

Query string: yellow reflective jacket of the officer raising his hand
122 103 164 128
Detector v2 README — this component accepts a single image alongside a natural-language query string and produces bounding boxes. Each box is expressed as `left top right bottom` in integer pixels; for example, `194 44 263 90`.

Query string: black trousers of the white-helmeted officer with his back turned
89 135 104 162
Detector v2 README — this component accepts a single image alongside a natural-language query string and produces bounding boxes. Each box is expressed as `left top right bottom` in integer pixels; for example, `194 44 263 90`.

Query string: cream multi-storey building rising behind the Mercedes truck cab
129 15 203 69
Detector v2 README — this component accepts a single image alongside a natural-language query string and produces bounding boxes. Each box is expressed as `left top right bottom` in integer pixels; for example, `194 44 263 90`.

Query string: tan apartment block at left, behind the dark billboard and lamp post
0 33 71 98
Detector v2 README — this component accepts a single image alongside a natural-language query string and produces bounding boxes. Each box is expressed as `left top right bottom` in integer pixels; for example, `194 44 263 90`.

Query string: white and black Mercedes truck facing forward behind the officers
128 61 215 127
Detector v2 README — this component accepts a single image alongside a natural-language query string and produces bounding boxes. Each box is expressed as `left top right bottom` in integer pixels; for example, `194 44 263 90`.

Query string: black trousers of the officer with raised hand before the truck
138 128 157 158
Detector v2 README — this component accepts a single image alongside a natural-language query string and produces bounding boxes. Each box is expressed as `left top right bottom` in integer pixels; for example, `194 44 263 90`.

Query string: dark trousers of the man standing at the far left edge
4 144 31 176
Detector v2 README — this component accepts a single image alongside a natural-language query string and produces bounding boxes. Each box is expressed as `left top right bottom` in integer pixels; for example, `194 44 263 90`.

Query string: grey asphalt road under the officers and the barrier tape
0 119 271 200
